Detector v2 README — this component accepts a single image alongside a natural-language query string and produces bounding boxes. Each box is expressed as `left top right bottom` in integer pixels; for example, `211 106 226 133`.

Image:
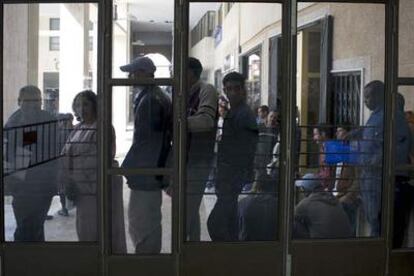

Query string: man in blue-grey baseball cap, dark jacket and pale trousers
120 57 172 254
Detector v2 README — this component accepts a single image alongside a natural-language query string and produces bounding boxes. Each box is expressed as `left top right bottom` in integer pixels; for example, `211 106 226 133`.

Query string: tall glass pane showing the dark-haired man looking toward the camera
185 3 281 241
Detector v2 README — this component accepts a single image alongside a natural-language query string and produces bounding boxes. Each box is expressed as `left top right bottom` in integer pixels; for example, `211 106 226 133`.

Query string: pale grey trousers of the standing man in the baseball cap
128 190 162 254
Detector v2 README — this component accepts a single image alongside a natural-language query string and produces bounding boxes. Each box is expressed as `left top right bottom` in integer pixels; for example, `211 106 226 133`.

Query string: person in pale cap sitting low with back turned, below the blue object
293 173 352 239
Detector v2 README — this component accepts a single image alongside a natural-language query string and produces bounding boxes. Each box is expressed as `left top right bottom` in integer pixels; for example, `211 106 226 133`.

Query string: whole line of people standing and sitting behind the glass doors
5 57 414 250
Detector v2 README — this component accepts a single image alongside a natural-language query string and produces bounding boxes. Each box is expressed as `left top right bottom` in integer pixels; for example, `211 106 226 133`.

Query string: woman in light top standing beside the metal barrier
60 90 98 241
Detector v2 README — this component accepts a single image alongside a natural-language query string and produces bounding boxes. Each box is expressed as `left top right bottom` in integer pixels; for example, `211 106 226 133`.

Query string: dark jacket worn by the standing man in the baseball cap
122 86 172 191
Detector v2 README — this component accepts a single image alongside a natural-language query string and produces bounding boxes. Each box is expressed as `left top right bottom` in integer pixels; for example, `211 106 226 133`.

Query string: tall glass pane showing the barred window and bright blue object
293 3 385 239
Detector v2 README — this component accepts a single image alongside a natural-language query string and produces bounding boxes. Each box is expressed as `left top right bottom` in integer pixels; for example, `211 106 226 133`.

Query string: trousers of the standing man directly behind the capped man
186 159 212 241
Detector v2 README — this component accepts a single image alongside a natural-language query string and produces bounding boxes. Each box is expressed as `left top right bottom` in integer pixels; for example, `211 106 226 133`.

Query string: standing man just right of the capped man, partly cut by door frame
186 57 218 241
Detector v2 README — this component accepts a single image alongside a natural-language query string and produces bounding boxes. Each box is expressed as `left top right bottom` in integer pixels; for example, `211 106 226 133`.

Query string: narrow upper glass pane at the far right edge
398 0 414 77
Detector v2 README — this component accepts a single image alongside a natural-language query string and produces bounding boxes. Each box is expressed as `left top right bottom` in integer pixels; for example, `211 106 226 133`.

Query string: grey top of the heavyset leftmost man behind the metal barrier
4 109 60 195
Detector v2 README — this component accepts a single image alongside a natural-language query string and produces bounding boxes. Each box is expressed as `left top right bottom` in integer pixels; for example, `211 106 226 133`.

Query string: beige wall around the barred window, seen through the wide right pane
329 4 385 122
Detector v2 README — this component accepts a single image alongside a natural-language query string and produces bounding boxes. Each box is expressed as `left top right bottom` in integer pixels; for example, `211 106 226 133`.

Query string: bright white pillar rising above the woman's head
59 4 89 112
